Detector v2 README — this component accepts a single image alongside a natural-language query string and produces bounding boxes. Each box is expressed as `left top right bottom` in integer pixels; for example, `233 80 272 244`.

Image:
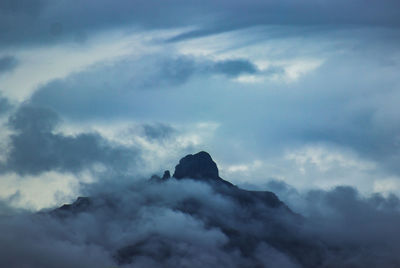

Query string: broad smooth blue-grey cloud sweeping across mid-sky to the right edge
21 27 399 184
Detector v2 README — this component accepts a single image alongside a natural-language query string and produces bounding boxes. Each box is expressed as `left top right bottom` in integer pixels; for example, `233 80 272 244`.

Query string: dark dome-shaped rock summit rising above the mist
173 151 219 179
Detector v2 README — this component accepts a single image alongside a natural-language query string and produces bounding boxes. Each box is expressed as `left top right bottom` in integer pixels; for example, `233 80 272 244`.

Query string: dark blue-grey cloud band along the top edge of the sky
0 0 400 46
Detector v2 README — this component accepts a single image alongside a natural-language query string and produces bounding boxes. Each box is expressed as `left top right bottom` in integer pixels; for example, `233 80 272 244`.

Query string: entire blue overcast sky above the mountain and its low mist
0 0 400 210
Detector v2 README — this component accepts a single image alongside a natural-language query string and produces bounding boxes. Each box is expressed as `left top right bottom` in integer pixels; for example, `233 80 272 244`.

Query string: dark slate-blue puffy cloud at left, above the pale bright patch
2 105 138 175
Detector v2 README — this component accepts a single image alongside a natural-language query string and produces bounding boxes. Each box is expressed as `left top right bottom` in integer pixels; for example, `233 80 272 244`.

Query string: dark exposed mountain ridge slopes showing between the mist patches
51 151 320 267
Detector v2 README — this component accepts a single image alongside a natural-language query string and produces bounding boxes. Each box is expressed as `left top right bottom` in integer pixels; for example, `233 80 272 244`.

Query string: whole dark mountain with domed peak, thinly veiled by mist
51 151 323 267
